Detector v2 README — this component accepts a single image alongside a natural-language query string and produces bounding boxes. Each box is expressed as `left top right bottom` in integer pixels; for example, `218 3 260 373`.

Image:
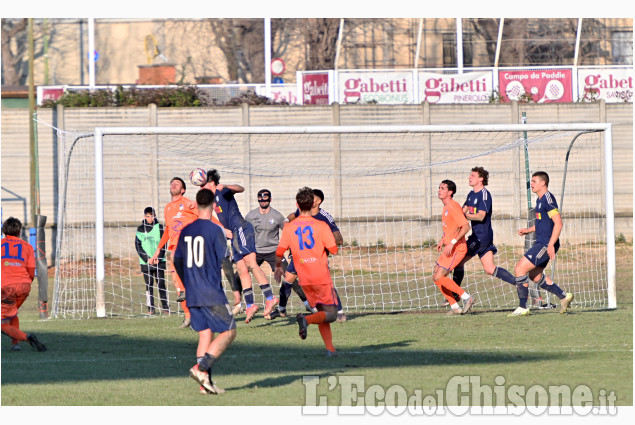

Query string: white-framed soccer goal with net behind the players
52 124 616 318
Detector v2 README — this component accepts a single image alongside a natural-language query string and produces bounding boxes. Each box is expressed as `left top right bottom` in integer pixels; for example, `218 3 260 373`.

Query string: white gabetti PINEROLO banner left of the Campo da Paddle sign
419 71 494 103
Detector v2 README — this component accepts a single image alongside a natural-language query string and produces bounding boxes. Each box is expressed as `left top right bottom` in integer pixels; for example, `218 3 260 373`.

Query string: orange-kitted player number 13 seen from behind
274 187 338 357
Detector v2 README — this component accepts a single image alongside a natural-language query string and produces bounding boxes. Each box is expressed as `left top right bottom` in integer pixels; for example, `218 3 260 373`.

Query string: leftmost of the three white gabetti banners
338 71 413 104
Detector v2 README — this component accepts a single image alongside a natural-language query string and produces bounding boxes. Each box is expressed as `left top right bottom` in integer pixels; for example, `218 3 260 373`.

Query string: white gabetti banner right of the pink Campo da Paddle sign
578 69 633 103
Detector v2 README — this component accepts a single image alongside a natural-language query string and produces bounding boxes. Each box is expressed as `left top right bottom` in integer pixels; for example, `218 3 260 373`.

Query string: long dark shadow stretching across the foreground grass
2 323 570 388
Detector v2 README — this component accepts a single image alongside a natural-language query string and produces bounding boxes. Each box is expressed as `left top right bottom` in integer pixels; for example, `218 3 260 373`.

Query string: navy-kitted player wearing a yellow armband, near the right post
510 171 573 316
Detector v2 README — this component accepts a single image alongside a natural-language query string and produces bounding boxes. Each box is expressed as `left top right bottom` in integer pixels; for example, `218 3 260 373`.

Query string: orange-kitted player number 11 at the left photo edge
2 217 46 351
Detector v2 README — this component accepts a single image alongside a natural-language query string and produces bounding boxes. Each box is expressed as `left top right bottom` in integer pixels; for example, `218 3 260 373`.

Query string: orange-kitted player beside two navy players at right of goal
432 180 476 315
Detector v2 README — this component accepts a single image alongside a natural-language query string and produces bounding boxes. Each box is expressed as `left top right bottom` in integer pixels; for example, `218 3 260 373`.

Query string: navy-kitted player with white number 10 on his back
174 189 236 394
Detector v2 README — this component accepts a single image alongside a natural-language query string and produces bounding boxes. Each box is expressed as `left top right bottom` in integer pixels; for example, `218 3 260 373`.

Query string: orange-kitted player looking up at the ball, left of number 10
148 177 198 328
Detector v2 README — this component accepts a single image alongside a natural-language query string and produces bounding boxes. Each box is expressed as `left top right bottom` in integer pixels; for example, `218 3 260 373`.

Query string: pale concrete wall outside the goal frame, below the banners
2 103 633 262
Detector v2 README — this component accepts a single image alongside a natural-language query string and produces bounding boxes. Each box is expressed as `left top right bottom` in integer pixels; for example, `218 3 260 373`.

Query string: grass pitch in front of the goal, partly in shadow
1 244 633 410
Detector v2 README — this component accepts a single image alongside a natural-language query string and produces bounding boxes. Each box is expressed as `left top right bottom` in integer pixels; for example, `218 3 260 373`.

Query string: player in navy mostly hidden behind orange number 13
266 189 346 322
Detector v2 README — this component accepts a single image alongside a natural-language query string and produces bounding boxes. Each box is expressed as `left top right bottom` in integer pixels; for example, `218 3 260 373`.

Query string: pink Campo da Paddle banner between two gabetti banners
498 69 573 103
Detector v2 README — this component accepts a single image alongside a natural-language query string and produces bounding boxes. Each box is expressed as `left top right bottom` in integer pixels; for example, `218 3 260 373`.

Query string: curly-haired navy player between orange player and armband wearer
442 167 516 305
